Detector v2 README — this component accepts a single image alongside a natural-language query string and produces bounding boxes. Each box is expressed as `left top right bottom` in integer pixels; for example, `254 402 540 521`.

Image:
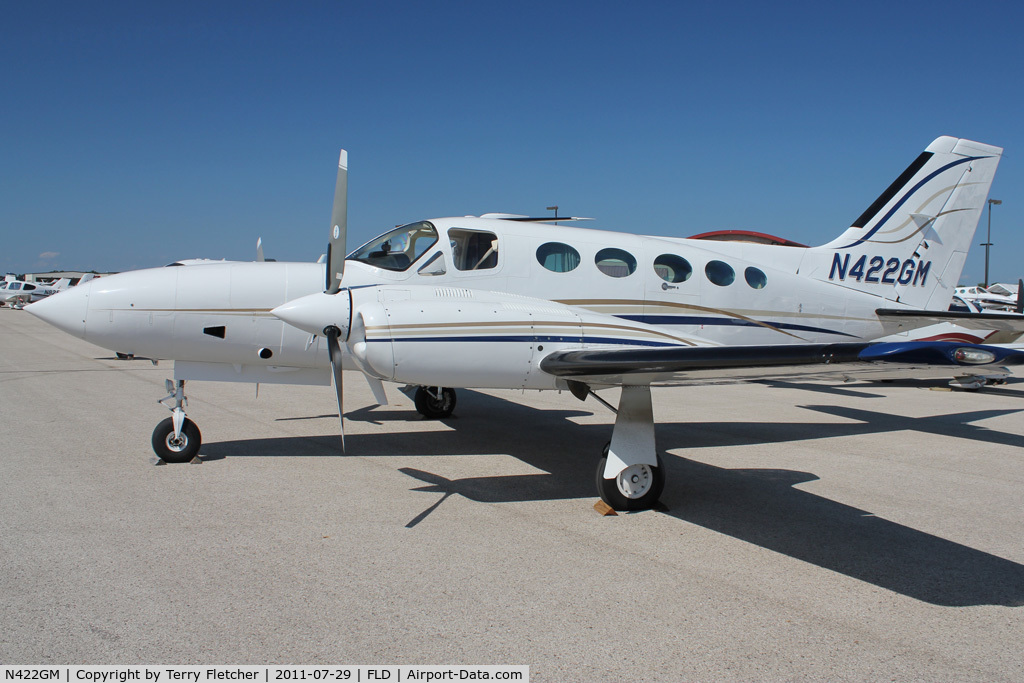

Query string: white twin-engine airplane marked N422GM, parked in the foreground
28 137 1024 510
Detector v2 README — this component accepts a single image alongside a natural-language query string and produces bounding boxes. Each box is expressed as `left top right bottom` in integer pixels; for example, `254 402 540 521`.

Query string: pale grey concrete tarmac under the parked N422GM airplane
0 308 1024 681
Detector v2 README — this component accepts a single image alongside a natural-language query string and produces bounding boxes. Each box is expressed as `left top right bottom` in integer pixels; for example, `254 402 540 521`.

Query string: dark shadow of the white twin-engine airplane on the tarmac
202 391 1024 606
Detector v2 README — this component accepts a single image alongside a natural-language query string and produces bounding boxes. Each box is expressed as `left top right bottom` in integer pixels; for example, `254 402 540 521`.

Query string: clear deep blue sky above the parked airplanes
0 0 1024 283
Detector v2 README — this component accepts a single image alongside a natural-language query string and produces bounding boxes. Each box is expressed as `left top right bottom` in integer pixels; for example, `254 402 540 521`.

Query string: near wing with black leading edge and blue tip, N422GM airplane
541 342 1024 386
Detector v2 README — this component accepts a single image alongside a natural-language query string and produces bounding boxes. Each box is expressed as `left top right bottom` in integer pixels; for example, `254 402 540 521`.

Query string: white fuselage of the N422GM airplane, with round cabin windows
34 217 929 388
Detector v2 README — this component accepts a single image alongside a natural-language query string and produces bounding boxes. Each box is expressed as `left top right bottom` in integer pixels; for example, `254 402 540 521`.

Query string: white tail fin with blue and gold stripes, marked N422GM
800 137 1002 309
